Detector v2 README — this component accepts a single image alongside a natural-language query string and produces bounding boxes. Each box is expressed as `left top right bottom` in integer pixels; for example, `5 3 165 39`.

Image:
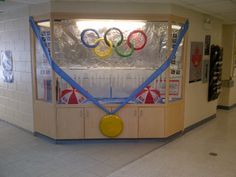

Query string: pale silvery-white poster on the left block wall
0 50 14 83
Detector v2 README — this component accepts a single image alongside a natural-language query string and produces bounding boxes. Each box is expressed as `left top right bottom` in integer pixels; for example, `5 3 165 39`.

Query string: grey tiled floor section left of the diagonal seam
0 121 164 177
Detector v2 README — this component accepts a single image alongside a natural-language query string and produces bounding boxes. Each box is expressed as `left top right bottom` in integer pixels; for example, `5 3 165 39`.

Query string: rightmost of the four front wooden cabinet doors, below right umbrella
138 108 165 138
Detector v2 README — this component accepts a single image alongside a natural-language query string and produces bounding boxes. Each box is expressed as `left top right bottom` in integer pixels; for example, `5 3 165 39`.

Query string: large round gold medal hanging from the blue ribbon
99 115 123 138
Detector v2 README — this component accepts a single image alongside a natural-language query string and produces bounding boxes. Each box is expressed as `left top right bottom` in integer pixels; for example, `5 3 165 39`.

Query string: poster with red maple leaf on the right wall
189 42 203 83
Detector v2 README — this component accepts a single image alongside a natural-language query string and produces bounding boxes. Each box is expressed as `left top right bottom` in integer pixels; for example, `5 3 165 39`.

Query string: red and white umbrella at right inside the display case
136 86 162 104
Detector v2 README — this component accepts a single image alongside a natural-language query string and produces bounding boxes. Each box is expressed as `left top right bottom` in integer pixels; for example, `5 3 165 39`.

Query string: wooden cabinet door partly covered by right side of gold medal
117 107 138 138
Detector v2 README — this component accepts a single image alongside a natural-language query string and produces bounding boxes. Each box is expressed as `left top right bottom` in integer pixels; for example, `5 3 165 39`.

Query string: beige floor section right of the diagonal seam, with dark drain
109 108 236 177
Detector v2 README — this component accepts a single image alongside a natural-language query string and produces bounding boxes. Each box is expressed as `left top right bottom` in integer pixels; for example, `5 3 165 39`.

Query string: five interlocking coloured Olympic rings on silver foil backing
81 27 147 59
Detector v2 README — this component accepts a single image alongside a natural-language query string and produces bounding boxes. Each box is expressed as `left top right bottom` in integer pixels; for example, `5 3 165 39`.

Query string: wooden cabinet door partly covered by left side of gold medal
85 107 111 139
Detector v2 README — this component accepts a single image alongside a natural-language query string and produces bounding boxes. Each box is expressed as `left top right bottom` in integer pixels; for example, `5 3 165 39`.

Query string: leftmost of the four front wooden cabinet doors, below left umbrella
57 108 84 139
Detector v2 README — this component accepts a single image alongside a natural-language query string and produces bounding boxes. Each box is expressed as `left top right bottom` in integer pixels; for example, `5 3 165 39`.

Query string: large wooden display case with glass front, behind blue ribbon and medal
30 14 188 139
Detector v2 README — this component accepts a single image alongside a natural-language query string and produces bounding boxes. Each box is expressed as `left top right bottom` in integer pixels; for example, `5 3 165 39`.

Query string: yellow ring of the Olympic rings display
94 38 113 59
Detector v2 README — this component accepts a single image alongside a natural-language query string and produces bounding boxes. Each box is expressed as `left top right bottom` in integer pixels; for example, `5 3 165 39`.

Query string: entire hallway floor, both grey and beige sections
0 108 236 177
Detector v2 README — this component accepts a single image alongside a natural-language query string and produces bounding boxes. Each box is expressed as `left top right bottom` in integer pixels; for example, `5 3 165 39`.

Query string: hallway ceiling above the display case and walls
0 0 236 24
